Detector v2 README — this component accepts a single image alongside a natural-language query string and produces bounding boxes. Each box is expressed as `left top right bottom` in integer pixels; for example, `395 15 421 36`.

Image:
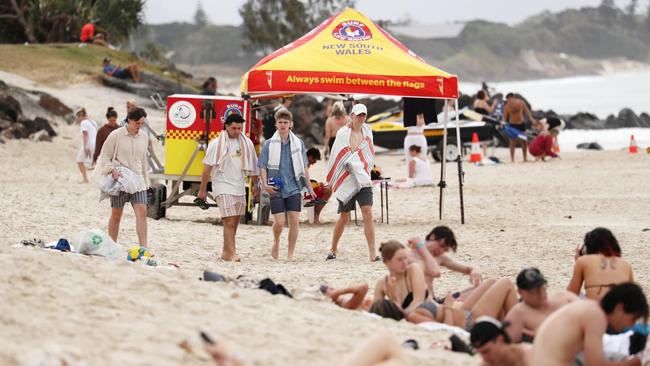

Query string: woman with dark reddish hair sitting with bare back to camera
567 227 634 300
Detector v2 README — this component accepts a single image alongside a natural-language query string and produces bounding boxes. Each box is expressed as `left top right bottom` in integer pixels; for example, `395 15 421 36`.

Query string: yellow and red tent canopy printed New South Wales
241 8 458 99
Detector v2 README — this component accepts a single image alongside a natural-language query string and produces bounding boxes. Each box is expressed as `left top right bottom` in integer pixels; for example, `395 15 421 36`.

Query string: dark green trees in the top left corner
0 0 144 43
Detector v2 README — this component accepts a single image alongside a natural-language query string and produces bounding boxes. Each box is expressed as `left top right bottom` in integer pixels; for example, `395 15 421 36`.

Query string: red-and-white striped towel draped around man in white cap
327 124 375 204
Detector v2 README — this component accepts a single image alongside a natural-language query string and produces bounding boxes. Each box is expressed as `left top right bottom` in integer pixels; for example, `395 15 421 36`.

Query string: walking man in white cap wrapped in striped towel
327 104 380 261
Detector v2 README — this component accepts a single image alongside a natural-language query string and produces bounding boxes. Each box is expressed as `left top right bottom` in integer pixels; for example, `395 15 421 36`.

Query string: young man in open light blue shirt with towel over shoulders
257 108 315 260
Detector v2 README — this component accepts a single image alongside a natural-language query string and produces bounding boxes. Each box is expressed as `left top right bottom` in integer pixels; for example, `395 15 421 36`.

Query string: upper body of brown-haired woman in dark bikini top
370 240 435 320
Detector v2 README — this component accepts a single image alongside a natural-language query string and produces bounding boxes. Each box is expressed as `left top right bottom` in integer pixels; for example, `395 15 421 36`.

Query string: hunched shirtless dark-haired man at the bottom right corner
533 282 648 366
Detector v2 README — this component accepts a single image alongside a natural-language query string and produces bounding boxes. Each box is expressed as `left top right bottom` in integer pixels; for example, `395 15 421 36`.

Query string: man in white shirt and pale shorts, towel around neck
197 113 258 262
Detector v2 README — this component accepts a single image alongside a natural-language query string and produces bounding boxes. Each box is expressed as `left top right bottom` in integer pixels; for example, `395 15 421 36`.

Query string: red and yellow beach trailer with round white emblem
147 94 251 220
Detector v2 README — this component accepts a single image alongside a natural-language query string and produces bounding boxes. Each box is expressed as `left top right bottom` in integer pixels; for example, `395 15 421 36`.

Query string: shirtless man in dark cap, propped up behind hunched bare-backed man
505 268 578 343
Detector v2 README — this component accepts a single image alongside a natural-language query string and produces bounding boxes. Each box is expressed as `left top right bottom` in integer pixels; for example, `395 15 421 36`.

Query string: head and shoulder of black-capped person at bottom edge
469 316 533 366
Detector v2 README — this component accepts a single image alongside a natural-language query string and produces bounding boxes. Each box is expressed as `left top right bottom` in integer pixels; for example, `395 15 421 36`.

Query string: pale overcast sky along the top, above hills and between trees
145 0 636 25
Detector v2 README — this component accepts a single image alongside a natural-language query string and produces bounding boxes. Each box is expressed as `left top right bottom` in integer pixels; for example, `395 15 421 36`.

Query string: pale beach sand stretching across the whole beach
0 73 650 365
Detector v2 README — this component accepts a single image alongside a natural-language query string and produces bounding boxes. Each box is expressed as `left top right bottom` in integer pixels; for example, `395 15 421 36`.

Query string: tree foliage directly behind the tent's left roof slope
239 0 355 53
